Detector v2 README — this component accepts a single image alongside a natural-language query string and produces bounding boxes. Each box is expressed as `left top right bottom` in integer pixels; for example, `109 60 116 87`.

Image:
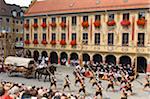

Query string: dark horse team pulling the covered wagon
35 65 56 82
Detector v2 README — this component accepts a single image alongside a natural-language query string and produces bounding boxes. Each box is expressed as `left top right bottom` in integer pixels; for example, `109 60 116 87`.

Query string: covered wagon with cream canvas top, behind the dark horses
4 56 36 78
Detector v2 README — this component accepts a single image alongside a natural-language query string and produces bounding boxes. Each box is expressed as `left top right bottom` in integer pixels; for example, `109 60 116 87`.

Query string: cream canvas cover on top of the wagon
4 56 34 68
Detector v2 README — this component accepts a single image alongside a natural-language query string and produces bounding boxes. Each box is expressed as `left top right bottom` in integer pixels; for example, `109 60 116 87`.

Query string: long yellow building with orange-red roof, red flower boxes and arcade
24 0 150 72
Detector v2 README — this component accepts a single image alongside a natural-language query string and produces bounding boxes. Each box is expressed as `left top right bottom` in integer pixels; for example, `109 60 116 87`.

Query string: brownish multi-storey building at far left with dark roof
0 0 23 57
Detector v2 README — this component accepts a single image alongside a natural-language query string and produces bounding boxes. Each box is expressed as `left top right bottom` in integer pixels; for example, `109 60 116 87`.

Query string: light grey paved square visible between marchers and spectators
0 66 150 99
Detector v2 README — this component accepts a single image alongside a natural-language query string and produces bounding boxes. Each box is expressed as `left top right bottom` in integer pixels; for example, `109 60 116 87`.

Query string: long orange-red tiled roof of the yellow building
25 0 150 16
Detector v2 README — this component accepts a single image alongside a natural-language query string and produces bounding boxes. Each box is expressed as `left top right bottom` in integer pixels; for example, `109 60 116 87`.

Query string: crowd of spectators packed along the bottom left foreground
0 81 82 99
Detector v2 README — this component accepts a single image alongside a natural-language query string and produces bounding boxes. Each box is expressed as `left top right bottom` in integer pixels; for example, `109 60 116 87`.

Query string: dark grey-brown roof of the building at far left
0 0 21 16
